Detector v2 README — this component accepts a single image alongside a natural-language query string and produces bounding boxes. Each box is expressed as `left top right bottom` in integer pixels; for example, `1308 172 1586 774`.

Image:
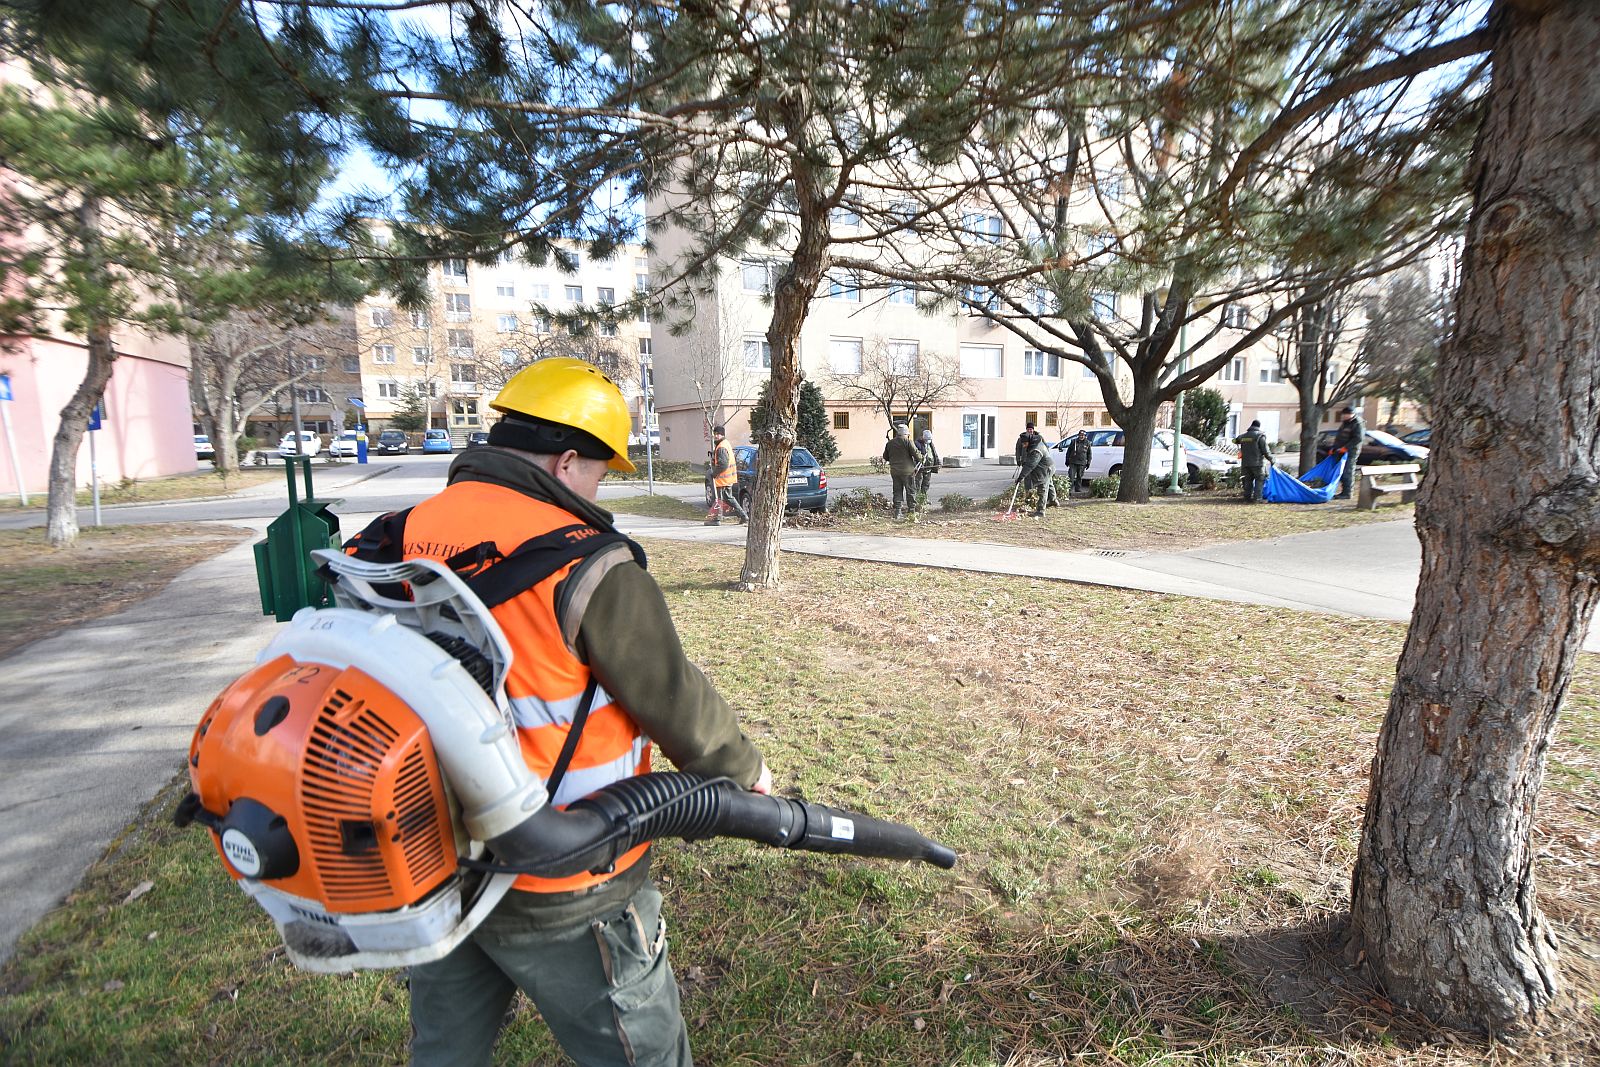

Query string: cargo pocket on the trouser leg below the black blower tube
594 888 683 1064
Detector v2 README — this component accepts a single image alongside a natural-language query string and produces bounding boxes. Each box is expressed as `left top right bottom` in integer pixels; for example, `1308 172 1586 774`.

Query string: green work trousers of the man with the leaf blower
411 881 693 1067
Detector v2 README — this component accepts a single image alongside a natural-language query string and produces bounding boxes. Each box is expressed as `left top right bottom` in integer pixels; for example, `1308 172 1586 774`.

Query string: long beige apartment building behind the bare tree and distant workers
654 242 1318 461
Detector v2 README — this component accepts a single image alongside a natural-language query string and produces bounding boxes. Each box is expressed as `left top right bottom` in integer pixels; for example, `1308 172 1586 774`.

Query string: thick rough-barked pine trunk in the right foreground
1352 0 1600 1030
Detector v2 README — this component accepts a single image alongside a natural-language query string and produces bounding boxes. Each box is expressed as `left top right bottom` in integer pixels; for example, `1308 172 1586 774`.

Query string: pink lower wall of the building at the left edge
0 336 195 496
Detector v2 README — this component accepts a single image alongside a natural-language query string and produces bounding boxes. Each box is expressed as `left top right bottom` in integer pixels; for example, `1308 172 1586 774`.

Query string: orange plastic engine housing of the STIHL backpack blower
189 656 456 913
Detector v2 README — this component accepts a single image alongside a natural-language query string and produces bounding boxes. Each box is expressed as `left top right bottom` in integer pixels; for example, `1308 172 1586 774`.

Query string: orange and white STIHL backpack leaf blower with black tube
174 550 955 973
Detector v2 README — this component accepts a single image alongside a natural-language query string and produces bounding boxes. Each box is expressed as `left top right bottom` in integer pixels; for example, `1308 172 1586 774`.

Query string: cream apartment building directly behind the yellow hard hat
355 246 651 443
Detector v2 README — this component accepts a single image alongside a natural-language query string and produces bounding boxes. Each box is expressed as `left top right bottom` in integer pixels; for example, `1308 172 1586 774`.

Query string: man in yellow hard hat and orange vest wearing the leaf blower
354 357 771 1067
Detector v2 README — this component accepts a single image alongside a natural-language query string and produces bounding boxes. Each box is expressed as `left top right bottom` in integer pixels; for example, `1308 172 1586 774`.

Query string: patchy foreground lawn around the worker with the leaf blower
0 542 1600 1067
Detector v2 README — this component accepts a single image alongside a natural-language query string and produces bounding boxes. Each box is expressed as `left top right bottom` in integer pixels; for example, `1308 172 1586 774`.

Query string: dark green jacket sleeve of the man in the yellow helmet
574 561 762 789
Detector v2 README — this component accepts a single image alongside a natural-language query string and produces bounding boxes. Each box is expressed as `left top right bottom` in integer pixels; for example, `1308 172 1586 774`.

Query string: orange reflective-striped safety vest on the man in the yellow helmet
405 482 650 893
